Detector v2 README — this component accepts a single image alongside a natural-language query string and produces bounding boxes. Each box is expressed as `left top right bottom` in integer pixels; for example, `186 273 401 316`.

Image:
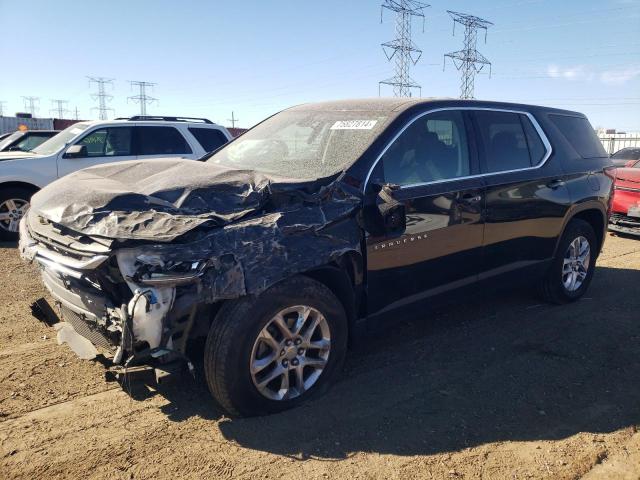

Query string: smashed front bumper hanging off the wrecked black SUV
19 216 202 366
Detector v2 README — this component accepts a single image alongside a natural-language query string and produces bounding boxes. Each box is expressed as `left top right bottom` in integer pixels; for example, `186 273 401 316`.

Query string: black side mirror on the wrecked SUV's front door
365 184 407 236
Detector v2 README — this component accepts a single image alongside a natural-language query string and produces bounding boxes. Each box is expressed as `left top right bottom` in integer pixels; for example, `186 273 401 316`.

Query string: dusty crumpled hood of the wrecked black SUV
29 158 284 241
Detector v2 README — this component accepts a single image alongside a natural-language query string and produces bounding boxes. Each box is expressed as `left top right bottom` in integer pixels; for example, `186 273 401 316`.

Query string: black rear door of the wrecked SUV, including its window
473 109 571 279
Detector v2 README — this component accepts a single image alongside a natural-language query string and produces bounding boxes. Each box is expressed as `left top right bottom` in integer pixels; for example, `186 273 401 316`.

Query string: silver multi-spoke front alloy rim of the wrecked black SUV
249 305 331 400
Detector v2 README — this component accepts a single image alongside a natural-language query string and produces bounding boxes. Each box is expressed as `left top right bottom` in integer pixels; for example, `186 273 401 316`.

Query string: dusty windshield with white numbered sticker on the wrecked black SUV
207 109 388 180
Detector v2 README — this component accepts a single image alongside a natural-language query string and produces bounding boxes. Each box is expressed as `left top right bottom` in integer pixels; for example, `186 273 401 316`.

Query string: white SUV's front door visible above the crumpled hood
58 125 136 177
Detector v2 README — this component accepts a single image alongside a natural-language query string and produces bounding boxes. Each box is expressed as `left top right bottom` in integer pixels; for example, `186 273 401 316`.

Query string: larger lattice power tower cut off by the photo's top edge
378 0 430 97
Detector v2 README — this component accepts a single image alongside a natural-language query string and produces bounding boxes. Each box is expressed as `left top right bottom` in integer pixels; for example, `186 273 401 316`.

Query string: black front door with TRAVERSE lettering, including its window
366 110 484 314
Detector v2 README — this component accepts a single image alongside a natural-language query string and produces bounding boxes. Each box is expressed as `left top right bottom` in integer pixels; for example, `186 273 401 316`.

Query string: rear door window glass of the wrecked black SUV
475 110 532 173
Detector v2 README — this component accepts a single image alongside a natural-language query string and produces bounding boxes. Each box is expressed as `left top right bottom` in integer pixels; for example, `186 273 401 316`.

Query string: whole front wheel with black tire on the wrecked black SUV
204 275 348 416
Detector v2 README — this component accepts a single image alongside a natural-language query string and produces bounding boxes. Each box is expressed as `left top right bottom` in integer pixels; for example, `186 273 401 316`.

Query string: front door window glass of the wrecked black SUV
382 110 470 185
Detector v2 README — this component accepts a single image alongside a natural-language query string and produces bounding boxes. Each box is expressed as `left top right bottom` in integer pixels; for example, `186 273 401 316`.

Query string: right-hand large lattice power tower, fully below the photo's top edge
442 10 493 98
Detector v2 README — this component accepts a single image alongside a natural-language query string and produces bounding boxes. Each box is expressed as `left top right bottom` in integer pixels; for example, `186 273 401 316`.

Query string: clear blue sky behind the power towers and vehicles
0 0 640 131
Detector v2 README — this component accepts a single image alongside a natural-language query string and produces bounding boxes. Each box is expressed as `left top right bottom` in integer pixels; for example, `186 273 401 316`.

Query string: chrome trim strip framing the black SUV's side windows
363 107 553 192
